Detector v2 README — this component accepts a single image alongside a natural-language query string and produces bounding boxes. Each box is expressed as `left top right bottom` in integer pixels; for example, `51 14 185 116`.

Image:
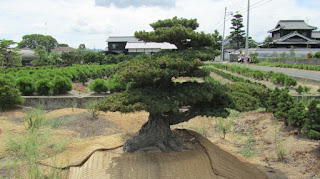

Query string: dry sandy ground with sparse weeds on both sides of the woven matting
0 107 320 179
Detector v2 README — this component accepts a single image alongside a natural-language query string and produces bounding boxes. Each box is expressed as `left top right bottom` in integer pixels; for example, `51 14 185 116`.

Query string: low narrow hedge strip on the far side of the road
257 62 320 71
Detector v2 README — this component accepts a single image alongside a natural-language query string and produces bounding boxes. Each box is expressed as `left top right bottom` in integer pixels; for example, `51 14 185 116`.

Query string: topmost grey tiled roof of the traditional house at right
269 20 317 32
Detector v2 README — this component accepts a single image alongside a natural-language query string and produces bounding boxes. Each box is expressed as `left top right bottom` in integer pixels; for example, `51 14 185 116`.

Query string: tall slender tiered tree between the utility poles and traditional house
229 14 245 49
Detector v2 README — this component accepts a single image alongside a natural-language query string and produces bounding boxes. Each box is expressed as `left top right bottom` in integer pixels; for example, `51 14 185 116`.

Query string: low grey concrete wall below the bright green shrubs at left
22 95 106 110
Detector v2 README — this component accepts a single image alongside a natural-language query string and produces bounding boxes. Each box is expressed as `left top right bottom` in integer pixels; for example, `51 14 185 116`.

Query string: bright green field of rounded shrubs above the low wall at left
0 65 111 96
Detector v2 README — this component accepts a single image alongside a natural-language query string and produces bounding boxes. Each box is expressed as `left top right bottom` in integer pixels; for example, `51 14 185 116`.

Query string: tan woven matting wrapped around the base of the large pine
41 130 267 179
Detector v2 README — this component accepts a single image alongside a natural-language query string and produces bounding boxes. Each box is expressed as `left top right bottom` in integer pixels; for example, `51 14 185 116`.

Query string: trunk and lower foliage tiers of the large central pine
97 57 230 152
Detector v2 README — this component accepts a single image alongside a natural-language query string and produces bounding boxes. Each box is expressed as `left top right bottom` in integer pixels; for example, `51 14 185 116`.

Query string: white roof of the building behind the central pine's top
125 42 178 50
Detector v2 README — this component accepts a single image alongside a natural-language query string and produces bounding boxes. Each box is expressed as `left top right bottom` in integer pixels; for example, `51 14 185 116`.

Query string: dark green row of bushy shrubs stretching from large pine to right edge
207 67 320 140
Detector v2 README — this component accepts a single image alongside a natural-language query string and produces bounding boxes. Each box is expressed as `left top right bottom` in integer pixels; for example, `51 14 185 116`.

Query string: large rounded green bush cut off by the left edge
0 76 22 110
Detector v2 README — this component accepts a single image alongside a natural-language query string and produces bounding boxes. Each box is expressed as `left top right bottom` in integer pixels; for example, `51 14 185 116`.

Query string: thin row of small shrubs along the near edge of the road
210 63 297 87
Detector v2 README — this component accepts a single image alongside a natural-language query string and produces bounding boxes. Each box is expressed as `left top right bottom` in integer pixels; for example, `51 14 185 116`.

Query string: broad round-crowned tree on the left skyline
18 34 59 52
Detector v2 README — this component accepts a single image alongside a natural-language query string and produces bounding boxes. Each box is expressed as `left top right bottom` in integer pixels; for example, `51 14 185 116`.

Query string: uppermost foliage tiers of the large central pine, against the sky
134 17 214 50
